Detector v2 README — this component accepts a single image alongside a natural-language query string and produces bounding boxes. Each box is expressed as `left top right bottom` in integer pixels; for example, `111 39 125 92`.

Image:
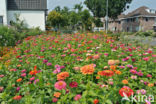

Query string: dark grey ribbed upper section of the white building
7 0 47 10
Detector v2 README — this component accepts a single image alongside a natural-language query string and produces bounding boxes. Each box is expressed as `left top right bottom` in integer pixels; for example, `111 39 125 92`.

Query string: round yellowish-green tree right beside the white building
47 10 63 27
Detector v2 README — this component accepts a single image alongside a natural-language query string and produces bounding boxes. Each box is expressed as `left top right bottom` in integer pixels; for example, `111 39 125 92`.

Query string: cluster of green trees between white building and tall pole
47 3 93 30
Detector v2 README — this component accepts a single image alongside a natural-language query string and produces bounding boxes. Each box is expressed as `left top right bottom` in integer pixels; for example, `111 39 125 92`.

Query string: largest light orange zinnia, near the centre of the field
80 64 95 75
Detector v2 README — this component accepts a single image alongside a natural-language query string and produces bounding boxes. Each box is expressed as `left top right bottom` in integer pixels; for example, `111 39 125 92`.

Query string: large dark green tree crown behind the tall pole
85 0 132 19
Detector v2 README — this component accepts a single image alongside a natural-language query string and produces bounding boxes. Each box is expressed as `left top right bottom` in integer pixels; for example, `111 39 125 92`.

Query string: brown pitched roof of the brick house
124 6 156 18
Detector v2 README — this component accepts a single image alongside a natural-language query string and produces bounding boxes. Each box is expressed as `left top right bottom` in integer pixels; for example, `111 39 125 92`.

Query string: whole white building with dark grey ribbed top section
0 0 47 30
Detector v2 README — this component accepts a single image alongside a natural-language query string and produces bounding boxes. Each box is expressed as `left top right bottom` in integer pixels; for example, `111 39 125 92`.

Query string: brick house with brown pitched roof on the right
108 6 156 32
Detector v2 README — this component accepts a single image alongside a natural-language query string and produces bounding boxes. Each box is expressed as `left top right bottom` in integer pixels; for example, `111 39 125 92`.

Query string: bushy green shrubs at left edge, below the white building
0 26 43 46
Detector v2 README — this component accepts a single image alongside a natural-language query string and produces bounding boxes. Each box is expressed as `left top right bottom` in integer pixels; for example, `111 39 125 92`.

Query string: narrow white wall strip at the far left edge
0 0 7 25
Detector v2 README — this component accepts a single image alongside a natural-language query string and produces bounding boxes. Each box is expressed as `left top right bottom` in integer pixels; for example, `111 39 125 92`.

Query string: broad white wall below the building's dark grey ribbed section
7 10 45 30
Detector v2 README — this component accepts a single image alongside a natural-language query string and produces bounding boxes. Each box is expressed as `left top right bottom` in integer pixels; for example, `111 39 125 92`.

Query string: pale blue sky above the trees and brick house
48 0 156 13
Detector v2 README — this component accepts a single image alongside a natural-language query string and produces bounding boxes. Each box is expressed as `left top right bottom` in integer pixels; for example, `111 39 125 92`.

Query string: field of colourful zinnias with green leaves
0 33 156 104
